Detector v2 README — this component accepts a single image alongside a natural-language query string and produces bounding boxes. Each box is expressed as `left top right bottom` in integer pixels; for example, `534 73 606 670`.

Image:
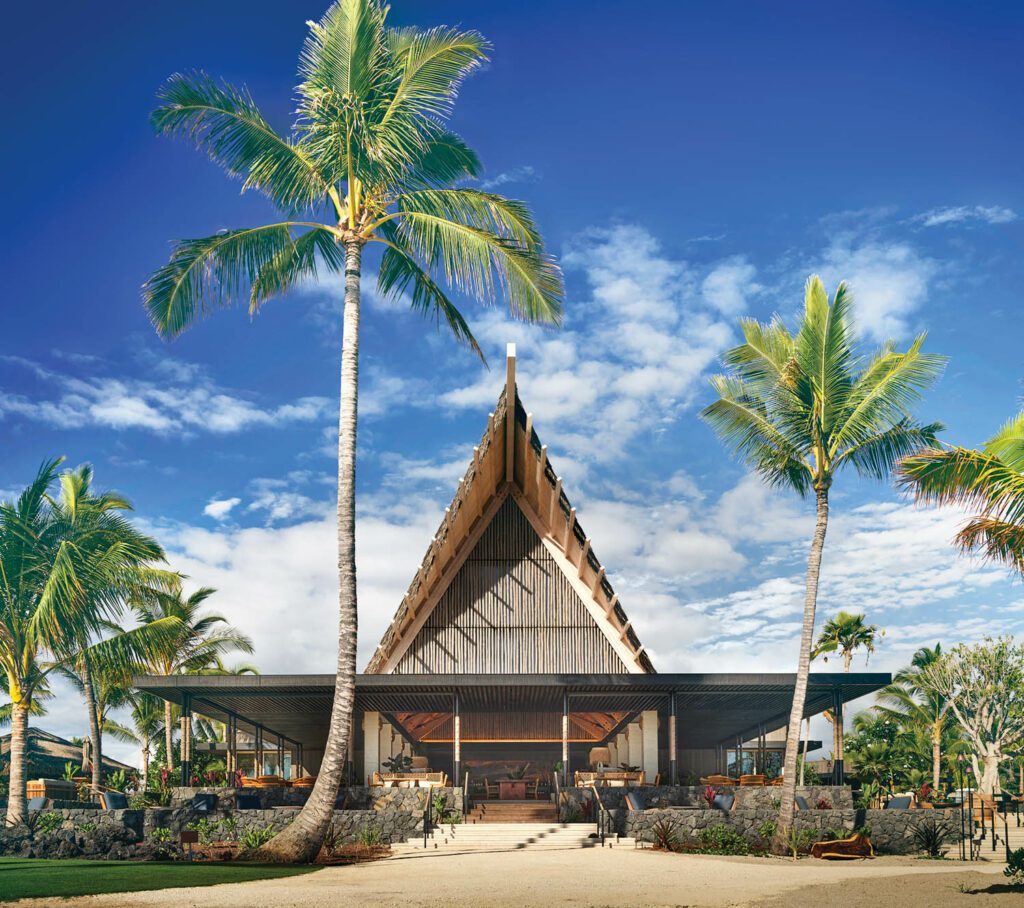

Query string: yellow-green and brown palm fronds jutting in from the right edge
897 409 1024 576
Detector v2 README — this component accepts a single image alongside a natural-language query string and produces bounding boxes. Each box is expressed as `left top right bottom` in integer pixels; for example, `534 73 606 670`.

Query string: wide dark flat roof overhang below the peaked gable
134 673 892 747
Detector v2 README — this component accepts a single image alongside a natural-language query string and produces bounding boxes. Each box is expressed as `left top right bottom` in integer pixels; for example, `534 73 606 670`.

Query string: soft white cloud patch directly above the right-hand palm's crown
819 237 938 341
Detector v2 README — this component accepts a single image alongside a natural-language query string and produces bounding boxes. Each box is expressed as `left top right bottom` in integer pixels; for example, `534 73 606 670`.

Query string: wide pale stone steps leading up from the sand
391 821 634 855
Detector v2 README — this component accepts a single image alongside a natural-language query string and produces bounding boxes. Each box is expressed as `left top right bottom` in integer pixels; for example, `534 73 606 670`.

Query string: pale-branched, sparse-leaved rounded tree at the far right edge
922 636 1024 793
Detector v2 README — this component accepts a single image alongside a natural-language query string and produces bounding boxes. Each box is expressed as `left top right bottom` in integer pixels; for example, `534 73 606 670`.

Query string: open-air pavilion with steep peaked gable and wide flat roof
135 352 891 783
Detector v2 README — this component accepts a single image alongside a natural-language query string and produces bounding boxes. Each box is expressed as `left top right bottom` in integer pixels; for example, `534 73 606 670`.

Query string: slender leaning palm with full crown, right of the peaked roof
701 274 943 853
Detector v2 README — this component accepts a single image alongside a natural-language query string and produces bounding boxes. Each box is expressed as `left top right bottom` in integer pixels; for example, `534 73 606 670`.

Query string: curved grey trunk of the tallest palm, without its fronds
261 241 362 863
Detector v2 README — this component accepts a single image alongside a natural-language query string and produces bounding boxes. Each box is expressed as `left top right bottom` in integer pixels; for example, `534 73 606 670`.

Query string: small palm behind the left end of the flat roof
132 587 253 773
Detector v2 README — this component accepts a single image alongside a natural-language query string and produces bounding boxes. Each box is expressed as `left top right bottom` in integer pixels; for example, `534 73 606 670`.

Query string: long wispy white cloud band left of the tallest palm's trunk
0 357 333 434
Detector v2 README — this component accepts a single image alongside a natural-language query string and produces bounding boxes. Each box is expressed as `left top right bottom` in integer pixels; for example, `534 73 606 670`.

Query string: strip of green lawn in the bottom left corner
0 858 319 903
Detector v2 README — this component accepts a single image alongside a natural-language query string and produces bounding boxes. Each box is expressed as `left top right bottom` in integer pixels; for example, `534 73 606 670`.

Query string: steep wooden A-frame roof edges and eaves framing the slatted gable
366 345 654 674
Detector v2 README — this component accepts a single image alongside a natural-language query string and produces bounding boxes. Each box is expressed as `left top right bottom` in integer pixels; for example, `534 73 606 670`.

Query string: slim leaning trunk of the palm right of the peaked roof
771 485 828 855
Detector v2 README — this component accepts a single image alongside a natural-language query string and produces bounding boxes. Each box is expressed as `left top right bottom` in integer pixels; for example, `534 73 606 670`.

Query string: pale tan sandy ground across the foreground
6 849 1024 908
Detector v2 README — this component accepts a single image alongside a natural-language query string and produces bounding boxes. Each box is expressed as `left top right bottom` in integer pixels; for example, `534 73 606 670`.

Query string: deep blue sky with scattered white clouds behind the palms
0 2 1024 765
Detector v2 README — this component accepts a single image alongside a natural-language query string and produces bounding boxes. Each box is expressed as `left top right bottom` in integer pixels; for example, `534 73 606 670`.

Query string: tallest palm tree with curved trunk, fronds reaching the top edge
144 0 562 860
